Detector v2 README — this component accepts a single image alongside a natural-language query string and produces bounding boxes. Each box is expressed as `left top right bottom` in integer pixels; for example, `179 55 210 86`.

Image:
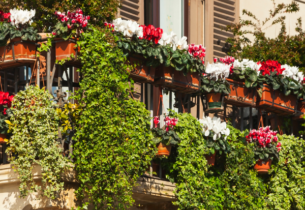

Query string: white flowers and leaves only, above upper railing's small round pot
202 62 231 94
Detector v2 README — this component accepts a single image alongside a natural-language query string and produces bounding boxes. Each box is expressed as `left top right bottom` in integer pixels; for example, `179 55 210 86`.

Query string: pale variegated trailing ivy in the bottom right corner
267 135 305 209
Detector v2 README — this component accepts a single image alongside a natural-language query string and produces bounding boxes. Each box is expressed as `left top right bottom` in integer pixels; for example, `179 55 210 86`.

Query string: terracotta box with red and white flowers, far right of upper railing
257 60 304 115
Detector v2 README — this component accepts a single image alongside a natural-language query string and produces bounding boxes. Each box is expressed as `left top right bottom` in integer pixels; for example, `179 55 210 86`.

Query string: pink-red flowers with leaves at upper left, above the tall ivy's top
52 9 90 40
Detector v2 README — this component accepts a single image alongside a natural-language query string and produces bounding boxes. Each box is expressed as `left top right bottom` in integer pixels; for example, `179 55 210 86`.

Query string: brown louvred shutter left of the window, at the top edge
118 0 144 24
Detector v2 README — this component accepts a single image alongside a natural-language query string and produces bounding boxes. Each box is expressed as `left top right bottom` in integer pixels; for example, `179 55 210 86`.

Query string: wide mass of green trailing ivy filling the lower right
155 114 305 210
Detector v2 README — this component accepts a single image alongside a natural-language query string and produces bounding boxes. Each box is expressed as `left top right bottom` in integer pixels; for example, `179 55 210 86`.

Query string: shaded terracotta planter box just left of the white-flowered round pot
154 65 200 93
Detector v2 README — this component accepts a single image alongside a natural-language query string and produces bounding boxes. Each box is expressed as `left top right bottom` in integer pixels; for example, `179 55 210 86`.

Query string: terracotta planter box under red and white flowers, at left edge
0 38 37 68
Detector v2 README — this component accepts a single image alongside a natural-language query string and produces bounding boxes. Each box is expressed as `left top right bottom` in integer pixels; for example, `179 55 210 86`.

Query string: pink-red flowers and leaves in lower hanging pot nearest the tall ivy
152 115 180 145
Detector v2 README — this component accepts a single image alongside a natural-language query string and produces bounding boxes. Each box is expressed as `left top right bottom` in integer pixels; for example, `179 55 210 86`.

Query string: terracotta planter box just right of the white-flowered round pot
224 79 257 107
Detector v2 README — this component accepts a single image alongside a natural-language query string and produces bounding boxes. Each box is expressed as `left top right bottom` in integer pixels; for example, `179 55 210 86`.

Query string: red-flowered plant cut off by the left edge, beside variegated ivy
0 91 14 144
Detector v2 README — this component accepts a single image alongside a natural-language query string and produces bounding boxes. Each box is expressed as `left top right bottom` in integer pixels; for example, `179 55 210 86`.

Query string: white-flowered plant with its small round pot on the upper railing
201 60 231 113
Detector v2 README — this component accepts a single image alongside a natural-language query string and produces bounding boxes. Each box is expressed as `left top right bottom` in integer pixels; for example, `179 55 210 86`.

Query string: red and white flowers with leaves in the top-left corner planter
0 9 41 46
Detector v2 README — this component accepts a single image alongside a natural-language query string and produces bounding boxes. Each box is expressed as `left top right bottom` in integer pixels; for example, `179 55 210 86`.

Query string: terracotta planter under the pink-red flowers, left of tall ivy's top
53 38 80 66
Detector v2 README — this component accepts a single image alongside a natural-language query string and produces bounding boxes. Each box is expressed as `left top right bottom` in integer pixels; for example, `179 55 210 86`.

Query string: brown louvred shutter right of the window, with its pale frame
205 0 239 62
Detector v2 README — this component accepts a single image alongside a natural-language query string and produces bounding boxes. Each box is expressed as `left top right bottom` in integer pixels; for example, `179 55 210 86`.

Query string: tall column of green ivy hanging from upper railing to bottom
73 28 156 209
